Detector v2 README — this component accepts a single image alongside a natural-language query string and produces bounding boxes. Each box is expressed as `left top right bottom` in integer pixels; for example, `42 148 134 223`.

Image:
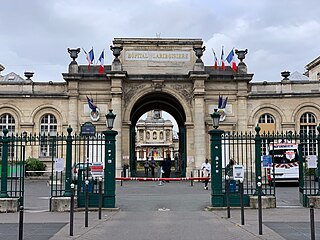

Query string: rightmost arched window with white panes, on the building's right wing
300 112 317 156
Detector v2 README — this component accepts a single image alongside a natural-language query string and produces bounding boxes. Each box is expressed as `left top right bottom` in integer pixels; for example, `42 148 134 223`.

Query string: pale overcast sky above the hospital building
0 0 320 81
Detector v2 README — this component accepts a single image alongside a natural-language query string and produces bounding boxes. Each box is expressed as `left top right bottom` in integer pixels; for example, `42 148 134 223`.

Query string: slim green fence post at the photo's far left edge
0 128 9 198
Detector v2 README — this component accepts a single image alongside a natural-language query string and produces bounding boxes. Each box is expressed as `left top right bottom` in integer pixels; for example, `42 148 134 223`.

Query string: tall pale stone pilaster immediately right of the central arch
190 72 208 169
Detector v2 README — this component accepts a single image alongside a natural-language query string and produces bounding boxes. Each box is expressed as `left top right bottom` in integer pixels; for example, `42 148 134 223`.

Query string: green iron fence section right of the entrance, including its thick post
209 126 320 207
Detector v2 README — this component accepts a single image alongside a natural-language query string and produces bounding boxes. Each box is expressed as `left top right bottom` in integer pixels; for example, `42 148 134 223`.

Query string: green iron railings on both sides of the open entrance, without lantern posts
0 127 320 209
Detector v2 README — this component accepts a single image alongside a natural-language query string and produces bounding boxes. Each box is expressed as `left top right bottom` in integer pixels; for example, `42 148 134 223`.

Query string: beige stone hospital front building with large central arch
0 38 320 175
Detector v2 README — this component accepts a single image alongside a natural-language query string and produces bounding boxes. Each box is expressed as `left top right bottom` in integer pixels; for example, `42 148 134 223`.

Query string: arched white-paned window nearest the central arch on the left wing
40 114 57 157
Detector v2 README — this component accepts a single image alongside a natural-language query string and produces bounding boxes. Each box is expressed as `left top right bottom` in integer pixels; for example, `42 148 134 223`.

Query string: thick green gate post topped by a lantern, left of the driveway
103 109 118 208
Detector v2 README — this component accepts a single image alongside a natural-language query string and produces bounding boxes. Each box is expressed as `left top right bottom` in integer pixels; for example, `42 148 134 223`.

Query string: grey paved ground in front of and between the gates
0 182 320 240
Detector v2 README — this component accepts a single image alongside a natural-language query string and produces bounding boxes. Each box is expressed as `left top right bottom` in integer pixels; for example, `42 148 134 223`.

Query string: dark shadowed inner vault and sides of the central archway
129 92 187 177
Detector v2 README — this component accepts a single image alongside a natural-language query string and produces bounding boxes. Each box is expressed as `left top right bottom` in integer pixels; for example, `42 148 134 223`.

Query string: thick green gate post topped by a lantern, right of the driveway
209 109 224 207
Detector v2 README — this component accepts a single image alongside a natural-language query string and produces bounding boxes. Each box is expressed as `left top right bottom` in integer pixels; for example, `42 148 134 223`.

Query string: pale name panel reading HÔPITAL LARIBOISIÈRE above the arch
125 51 191 62
